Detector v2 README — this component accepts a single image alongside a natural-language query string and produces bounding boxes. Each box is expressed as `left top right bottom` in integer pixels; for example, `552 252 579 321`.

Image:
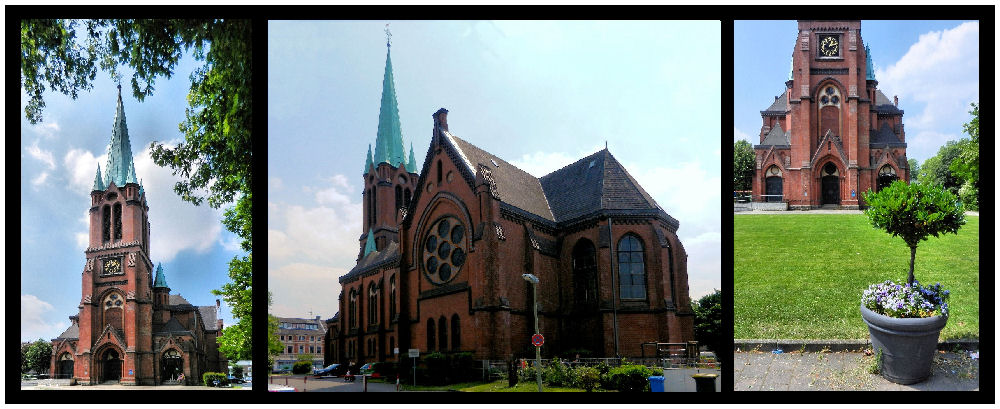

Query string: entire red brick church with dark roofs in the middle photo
325 36 694 363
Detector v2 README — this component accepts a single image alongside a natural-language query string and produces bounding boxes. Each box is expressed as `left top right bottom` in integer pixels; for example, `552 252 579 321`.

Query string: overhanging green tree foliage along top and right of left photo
21 19 253 360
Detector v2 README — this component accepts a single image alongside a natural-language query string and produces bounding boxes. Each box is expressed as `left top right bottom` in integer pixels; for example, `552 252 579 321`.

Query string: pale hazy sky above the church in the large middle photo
267 21 721 318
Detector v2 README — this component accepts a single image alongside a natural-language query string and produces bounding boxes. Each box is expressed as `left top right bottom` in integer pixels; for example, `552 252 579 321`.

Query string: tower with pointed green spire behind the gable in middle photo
358 29 417 260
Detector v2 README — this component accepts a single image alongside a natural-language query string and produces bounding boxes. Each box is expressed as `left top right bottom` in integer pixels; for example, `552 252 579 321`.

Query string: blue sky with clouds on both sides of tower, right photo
733 20 980 163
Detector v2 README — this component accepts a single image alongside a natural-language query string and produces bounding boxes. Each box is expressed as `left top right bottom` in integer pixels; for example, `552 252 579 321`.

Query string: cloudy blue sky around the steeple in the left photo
20 46 240 341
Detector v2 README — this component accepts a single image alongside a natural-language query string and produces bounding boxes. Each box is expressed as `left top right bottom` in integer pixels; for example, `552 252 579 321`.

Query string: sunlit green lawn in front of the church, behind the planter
733 214 979 339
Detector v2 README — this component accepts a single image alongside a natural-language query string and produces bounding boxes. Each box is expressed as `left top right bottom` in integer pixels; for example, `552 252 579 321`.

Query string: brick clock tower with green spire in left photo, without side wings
74 86 153 385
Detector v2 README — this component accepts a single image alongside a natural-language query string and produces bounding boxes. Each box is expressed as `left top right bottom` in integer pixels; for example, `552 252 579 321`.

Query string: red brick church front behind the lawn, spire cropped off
753 20 910 209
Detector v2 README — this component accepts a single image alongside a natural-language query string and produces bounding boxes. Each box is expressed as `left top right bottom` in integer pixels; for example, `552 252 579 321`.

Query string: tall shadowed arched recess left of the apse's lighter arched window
564 239 604 358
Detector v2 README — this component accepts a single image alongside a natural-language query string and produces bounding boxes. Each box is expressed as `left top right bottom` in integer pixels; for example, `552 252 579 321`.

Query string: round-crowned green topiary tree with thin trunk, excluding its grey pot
864 180 965 285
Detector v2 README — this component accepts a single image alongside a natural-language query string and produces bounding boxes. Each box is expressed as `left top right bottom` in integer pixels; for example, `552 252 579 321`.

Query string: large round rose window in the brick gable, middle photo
422 217 466 284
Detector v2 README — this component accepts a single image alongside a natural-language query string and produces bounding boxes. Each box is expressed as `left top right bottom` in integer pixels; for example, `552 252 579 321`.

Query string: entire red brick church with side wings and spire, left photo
51 87 226 385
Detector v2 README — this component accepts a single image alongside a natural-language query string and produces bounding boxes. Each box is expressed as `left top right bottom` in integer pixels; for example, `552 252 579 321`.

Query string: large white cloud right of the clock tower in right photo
875 22 979 158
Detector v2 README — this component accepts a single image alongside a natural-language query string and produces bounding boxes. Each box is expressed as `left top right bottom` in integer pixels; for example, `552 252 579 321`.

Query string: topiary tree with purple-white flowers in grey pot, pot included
861 180 965 385
